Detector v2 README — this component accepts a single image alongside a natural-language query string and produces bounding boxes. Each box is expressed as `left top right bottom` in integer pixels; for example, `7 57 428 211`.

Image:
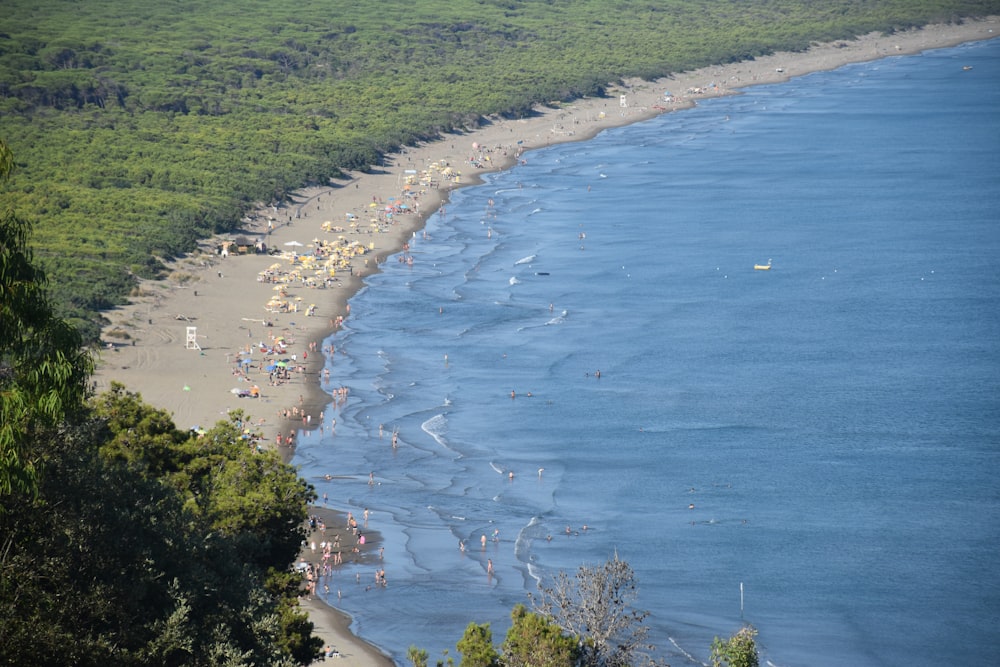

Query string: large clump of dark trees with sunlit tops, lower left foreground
0 387 322 667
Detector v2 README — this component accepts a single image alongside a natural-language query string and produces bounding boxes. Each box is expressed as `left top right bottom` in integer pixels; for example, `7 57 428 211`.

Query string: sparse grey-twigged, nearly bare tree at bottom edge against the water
532 553 653 667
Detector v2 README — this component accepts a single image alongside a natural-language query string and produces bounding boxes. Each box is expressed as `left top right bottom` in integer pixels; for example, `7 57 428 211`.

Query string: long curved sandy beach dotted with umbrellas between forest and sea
94 17 1000 666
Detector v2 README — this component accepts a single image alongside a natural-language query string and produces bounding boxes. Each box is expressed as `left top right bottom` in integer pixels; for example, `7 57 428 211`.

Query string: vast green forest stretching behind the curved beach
0 0 1000 341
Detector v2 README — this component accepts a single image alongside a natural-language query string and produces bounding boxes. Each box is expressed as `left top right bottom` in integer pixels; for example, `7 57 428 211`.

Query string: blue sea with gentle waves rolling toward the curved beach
294 40 1000 667
